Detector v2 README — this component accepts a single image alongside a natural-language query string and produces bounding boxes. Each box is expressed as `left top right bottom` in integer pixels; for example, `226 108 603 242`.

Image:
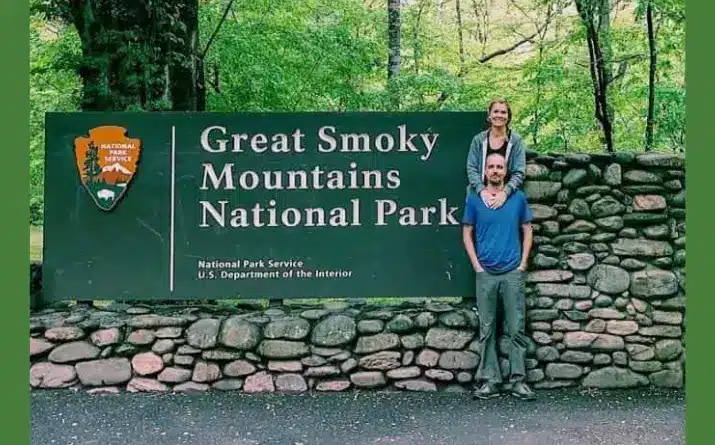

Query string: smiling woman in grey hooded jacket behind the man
467 99 526 209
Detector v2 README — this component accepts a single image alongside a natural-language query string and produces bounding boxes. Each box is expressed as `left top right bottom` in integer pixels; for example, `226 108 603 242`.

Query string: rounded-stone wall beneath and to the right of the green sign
30 153 685 393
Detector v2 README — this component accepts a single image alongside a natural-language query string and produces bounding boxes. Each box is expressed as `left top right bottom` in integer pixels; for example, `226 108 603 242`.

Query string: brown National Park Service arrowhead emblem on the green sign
74 126 141 211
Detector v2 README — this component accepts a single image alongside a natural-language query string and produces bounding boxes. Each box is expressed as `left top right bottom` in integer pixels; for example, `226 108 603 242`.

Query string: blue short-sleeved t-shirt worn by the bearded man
462 190 532 274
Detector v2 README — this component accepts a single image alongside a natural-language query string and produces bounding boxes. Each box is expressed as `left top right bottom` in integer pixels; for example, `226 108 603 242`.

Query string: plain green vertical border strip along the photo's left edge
0 1 30 445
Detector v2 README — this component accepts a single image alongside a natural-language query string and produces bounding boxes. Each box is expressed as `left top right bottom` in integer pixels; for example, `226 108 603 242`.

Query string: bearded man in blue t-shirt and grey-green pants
462 153 534 399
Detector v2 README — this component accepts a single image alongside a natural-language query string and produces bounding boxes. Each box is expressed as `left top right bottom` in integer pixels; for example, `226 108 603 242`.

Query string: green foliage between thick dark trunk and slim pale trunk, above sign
200 0 387 111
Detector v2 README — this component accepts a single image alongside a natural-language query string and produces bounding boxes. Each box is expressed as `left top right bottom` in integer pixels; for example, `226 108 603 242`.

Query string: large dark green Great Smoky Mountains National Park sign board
43 112 485 300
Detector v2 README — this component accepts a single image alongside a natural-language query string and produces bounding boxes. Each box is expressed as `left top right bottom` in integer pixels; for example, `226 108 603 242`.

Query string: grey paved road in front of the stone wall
31 389 685 445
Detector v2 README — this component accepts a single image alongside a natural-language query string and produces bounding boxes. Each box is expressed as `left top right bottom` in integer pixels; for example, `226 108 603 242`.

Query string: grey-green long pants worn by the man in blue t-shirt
475 269 528 384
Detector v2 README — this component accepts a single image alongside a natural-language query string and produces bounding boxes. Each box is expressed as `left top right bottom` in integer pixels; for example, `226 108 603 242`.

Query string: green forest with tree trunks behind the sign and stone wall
29 0 685 227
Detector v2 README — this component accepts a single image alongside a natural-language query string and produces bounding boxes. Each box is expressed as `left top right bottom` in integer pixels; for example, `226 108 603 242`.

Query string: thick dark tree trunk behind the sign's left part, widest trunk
64 0 199 111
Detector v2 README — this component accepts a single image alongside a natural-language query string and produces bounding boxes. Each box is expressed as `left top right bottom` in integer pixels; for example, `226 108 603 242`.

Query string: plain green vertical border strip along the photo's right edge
685 0 715 445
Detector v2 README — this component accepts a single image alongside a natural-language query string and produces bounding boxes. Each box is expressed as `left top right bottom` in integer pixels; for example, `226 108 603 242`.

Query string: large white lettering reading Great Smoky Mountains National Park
199 124 459 231
